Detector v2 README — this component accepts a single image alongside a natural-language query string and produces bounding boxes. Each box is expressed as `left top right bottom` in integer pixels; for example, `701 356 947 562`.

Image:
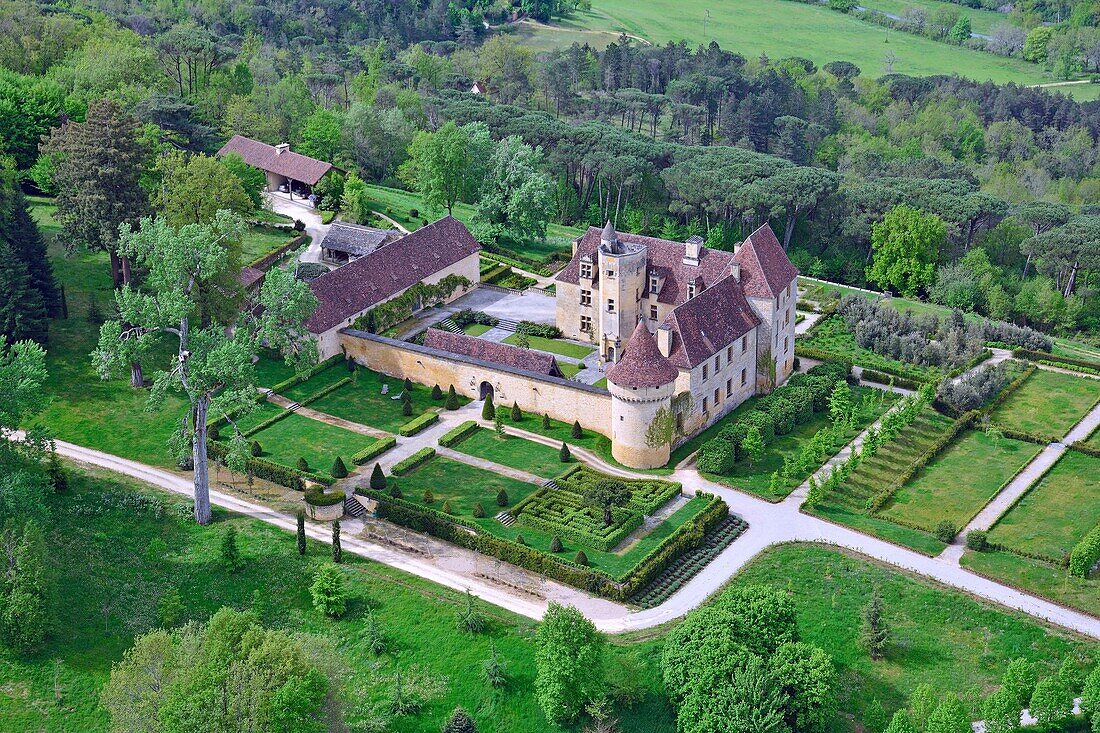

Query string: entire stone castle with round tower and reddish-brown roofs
556 222 799 468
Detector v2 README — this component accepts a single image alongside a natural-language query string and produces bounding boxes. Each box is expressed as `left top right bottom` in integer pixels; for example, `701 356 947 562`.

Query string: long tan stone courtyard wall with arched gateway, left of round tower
340 328 612 436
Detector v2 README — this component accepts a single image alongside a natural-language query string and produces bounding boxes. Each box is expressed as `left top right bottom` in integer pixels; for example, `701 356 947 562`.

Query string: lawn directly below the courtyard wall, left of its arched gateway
287 367 457 433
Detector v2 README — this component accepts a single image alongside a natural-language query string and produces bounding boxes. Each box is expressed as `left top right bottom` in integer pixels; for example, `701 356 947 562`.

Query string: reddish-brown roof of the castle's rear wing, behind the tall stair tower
556 227 734 306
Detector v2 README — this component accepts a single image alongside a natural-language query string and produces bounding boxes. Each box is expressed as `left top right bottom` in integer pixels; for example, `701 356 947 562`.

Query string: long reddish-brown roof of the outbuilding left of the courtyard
306 217 481 333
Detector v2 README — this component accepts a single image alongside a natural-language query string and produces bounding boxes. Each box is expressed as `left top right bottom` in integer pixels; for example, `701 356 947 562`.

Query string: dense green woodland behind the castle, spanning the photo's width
0 0 1100 341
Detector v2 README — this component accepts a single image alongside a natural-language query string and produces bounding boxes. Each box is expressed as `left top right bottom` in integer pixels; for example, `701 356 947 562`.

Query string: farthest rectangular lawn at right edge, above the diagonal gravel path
992 369 1100 439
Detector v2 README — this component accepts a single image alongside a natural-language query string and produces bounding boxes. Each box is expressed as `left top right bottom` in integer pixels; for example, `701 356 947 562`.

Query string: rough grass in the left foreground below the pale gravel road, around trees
0 464 675 733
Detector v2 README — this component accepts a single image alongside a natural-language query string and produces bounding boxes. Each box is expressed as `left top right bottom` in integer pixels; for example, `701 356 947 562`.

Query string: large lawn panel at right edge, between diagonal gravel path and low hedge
989 450 1100 560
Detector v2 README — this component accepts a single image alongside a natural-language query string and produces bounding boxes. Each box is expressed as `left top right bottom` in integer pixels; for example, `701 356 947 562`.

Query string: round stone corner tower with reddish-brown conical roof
607 320 679 469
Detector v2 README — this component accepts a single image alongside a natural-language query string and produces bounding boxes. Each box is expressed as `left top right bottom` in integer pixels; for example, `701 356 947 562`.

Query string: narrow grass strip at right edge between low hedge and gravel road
959 550 1100 616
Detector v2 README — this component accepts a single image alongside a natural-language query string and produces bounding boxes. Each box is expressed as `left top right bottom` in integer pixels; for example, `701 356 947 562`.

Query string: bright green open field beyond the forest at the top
539 0 1049 84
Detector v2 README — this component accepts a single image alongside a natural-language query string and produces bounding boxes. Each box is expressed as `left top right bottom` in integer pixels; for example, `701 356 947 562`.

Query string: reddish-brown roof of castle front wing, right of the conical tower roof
664 275 760 369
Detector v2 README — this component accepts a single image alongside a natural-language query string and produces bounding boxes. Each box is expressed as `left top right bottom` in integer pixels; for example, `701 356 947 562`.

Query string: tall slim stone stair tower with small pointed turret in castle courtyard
595 221 646 364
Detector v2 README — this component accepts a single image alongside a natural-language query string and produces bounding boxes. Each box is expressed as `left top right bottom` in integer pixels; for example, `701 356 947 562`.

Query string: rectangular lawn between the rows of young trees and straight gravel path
879 430 1042 530
